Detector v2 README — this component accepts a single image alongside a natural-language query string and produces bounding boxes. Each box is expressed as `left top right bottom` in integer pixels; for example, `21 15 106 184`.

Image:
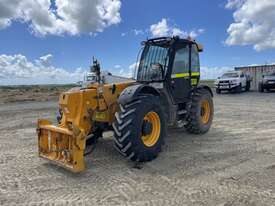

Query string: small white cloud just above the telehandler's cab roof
150 18 204 38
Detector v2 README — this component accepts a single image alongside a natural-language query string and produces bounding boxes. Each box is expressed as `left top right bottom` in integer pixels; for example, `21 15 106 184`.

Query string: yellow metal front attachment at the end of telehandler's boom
37 120 85 172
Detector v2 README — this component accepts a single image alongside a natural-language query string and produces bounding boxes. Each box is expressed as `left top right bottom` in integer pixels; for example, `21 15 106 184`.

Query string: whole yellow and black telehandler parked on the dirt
37 37 214 172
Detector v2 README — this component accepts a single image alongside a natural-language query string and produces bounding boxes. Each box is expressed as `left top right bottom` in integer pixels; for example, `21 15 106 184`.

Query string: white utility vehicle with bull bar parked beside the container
215 71 251 94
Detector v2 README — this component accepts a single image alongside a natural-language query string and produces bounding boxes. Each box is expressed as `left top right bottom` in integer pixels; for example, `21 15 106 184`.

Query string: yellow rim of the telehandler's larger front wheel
141 112 161 147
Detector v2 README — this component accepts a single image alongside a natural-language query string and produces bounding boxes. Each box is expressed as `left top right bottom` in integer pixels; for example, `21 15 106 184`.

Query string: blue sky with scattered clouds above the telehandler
0 0 275 84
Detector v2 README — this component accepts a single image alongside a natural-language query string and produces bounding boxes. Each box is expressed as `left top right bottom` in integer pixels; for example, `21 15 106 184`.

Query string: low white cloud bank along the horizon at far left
0 54 84 85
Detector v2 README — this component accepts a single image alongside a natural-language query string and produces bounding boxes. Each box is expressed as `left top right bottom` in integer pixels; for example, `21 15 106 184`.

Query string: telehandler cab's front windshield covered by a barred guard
137 45 169 81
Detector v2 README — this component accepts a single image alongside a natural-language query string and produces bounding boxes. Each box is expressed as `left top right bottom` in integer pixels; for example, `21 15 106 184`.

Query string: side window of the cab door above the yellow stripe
172 45 189 74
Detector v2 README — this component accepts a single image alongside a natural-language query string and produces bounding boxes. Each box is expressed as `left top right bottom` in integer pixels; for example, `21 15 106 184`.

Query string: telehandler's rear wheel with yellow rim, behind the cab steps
185 89 214 134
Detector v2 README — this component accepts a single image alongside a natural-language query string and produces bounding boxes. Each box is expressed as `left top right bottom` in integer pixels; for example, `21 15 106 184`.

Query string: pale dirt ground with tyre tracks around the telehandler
0 92 275 206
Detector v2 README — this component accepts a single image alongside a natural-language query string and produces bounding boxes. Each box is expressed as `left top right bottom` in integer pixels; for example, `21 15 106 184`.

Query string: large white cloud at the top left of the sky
0 0 121 36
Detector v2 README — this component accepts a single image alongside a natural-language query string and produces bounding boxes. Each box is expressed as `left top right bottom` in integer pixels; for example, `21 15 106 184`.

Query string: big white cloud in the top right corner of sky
225 0 275 51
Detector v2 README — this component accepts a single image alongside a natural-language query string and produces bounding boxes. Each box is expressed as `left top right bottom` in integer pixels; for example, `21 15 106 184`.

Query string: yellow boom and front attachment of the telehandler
37 81 134 172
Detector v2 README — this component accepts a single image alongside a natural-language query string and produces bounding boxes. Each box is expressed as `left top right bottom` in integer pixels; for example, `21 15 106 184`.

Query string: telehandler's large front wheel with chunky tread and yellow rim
113 95 166 162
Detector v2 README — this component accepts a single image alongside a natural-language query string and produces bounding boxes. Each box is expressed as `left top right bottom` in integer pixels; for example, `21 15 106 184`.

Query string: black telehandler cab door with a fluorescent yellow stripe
170 44 192 103
